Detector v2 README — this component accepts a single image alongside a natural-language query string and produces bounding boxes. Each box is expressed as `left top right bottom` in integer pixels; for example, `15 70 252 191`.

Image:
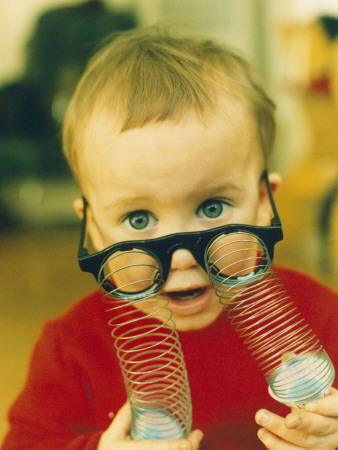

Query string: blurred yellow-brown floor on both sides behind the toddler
0 193 338 442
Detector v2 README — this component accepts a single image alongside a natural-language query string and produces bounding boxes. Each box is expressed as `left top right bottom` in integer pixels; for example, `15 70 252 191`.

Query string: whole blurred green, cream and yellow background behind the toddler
0 0 338 441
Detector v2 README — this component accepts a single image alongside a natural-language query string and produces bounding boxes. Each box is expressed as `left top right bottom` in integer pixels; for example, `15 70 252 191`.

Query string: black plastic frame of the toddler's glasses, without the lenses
78 171 283 294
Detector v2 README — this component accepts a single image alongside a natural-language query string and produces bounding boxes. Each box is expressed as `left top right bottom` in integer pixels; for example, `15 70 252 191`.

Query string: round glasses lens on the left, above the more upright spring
100 248 162 298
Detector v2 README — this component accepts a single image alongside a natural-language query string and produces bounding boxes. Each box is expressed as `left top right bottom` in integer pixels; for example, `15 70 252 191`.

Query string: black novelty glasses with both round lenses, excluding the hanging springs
78 171 283 301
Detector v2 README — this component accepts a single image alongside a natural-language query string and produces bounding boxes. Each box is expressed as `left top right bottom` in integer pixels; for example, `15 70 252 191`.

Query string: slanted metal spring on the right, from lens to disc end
206 233 335 406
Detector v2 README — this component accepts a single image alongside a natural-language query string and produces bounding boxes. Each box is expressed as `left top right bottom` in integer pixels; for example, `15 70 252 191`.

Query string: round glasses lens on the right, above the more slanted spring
206 232 269 284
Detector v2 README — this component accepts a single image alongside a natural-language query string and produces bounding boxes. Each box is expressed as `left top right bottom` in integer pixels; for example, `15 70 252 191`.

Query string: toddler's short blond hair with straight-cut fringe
63 25 275 180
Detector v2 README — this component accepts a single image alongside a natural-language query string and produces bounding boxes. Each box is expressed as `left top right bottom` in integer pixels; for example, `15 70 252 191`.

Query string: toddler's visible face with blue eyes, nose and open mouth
78 104 274 331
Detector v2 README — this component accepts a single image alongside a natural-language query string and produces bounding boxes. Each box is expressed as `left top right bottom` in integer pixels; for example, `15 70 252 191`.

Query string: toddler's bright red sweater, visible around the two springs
2 268 338 450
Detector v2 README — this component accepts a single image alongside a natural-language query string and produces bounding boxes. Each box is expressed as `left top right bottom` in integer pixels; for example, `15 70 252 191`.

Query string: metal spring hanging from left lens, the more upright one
101 265 192 440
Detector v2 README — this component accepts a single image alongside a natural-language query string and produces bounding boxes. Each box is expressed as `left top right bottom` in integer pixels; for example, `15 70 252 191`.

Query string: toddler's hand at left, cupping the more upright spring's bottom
97 402 203 450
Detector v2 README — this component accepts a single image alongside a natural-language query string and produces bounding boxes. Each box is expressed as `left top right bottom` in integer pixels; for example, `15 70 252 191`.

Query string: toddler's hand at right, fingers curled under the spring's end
256 388 338 450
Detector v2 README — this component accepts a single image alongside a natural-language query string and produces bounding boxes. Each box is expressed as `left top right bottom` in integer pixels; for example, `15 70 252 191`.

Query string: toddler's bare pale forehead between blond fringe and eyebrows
81 101 263 199
